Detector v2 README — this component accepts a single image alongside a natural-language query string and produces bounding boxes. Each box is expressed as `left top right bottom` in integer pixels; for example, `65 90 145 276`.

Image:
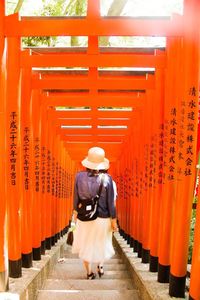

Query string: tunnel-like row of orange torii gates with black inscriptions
0 0 200 300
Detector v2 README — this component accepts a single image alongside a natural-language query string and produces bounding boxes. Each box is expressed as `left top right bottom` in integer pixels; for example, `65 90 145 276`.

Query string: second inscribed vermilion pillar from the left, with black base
21 52 33 268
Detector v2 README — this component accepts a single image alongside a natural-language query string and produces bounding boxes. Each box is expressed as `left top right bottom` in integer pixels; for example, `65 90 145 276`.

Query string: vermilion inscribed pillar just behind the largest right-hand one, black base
158 38 182 282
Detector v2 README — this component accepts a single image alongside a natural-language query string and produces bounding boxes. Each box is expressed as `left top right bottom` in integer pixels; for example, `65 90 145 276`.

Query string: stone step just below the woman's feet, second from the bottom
43 277 134 290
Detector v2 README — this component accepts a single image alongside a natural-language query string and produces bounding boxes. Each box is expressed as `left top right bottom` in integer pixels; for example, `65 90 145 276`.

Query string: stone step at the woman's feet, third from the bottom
48 267 130 280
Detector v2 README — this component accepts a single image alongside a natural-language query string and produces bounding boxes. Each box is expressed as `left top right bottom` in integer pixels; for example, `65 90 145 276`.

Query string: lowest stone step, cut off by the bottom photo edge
37 290 139 300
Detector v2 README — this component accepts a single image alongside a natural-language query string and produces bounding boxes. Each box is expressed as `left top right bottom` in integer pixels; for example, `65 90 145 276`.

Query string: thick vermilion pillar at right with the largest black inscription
169 0 200 297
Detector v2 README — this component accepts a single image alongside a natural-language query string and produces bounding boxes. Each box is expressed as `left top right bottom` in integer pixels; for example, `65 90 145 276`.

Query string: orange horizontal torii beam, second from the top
21 52 166 68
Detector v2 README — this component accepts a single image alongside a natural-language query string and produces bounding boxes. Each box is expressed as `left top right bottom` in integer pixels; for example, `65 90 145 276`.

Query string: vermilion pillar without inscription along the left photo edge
0 1 8 292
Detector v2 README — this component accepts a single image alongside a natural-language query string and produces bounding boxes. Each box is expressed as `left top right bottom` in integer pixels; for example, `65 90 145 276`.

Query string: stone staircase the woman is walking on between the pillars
37 240 140 300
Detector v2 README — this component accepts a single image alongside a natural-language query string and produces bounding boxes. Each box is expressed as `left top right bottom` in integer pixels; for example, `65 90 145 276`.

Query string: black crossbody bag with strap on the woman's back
77 176 104 221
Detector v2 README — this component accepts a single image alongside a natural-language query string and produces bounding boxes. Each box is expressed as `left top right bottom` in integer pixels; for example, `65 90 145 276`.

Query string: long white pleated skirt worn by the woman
72 218 115 263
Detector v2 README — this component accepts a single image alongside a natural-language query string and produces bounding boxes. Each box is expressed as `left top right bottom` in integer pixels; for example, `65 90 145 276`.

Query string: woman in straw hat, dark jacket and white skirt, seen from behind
72 147 117 279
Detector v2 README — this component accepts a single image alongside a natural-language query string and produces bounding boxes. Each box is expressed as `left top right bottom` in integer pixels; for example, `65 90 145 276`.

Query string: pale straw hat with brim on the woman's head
82 147 109 170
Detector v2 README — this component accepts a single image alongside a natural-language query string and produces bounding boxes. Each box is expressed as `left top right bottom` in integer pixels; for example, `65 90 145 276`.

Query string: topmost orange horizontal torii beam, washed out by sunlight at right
5 14 183 37
